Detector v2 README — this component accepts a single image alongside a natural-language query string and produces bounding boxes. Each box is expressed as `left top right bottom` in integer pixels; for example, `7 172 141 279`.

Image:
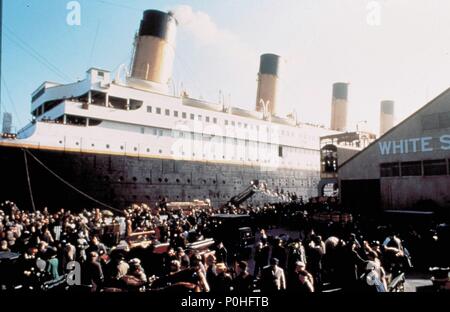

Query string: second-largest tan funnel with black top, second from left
256 54 280 115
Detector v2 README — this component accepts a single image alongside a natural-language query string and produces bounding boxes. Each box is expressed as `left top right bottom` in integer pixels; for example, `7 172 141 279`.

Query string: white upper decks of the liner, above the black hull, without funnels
12 68 333 171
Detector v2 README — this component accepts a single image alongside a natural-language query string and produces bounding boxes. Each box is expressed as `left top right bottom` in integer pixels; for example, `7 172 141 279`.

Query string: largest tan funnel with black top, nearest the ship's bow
130 10 177 89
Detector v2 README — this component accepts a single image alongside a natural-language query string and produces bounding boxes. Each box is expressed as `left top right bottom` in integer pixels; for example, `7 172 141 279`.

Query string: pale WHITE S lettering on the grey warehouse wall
378 134 450 156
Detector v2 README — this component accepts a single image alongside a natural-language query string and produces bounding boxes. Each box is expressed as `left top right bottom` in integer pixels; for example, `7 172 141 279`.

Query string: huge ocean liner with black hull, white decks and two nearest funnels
0 10 337 209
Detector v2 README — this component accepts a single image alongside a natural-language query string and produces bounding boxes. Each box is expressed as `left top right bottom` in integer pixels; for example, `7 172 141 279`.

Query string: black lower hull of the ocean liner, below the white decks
0 146 319 209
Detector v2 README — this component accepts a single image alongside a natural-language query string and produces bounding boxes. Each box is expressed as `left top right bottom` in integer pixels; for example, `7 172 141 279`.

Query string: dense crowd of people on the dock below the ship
0 197 446 293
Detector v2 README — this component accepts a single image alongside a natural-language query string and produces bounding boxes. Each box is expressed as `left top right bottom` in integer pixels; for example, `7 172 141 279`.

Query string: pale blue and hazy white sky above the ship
1 0 450 133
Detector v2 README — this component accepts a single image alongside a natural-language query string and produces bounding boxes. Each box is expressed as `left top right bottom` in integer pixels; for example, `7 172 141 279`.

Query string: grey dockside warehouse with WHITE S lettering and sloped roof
338 89 450 213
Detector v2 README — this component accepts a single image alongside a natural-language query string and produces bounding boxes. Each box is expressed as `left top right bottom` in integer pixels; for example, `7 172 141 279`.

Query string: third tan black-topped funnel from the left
331 82 349 131
